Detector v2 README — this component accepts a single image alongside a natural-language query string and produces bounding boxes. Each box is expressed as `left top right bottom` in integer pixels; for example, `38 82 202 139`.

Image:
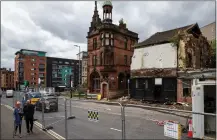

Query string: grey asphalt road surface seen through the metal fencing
2 91 190 139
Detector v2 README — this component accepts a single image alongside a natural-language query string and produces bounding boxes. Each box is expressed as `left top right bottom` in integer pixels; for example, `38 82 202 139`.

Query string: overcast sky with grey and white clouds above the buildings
1 1 216 69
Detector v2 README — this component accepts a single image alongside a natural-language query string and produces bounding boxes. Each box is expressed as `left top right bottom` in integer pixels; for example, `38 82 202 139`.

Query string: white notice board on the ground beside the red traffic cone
164 121 182 140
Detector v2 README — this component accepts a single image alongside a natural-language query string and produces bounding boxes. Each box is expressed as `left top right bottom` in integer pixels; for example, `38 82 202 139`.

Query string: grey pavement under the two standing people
1 105 54 139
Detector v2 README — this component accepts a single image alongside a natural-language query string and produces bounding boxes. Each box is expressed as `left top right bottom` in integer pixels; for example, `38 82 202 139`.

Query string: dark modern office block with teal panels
46 57 79 87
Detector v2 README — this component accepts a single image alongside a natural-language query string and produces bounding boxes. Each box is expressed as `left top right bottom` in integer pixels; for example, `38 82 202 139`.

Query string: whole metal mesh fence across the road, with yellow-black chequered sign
13 93 216 139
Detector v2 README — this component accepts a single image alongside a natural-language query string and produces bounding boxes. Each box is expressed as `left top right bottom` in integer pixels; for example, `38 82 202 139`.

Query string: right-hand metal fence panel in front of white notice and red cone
124 104 216 139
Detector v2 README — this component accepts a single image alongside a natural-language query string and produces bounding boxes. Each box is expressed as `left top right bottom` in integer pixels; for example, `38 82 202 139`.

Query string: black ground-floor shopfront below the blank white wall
130 77 177 102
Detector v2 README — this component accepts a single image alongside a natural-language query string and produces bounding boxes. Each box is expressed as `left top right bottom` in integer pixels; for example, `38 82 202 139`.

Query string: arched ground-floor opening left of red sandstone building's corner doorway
90 71 100 93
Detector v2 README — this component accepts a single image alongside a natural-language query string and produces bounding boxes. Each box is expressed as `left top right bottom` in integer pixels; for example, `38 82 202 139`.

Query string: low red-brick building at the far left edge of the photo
0 68 14 90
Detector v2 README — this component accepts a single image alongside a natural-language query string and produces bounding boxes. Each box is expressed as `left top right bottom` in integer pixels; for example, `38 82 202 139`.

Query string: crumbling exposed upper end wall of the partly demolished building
177 32 211 70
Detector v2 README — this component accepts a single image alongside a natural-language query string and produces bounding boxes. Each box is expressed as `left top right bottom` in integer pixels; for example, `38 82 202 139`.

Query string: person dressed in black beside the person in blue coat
23 100 35 134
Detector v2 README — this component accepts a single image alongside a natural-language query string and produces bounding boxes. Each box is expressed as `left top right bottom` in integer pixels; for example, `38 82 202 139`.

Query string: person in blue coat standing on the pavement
13 101 23 138
